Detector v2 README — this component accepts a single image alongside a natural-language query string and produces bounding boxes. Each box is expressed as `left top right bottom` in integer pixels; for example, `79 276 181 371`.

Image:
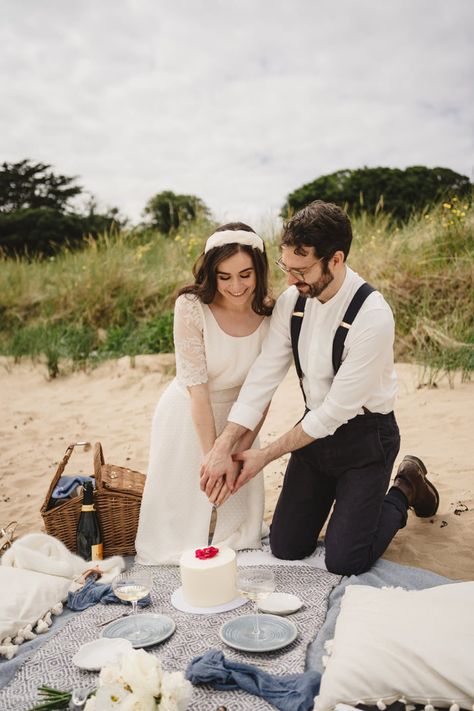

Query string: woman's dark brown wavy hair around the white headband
178 222 275 316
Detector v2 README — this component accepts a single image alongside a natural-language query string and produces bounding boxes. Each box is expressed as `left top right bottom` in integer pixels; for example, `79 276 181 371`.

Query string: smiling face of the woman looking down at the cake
216 252 257 306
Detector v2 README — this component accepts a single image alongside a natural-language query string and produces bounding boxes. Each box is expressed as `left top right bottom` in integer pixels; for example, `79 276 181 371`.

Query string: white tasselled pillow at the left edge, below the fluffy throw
0 565 71 658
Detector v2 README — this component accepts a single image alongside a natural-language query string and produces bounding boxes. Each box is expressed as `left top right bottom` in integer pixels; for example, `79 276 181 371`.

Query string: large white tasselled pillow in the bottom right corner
314 582 474 711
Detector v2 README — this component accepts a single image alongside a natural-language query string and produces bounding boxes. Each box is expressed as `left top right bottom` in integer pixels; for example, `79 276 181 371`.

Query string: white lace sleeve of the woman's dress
174 294 208 385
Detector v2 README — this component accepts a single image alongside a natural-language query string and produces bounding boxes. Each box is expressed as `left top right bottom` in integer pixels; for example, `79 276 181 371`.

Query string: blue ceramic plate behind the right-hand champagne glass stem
219 615 298 652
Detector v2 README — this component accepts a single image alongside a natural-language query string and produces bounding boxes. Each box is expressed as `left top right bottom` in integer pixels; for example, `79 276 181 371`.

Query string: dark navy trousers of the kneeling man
270 412 408 575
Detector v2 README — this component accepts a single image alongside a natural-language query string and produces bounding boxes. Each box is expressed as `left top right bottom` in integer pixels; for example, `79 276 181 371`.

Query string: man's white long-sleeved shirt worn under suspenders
228 267 397 439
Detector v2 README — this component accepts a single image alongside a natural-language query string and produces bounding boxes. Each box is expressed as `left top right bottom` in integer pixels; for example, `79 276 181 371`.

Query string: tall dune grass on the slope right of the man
351 200 474 379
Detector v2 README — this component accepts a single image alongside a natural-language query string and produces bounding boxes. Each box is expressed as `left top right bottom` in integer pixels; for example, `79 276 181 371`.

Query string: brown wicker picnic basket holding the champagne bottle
41 442 145 558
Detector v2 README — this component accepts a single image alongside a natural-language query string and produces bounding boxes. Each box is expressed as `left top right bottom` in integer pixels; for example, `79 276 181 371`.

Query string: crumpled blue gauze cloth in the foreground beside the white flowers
186 649 321 711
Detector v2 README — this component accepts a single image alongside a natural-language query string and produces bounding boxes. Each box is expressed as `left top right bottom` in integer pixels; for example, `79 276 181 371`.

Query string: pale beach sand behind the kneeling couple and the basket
0 355 474 580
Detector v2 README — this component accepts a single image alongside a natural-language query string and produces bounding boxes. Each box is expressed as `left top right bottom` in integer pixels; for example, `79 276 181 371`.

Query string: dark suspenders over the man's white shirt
290 282 375 409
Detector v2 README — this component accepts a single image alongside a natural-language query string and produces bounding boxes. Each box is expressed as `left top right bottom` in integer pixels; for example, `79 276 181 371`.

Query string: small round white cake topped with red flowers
179 547 237 607
